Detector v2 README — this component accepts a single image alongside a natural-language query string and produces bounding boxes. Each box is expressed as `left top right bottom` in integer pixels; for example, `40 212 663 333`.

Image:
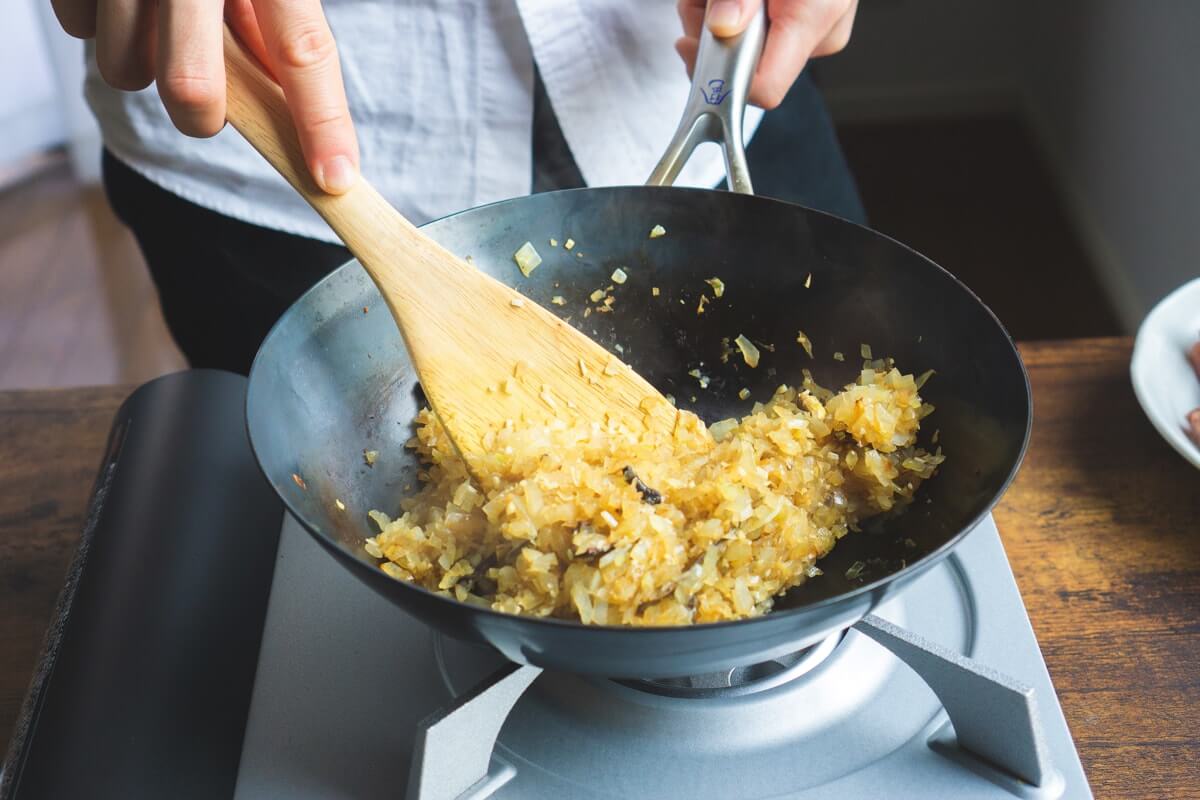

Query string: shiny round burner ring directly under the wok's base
614 631 846 699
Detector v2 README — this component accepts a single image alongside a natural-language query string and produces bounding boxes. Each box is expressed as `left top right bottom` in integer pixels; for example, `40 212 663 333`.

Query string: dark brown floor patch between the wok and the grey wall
838 116 1122 339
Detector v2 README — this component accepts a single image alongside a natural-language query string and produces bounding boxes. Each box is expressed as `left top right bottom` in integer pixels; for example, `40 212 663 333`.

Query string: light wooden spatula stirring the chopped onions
224 29 676 467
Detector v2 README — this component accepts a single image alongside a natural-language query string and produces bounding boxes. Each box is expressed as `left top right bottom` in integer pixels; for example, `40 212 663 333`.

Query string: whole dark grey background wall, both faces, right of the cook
821 0 1200 332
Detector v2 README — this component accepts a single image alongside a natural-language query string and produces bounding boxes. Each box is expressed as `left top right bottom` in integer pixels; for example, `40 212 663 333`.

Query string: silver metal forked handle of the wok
646 4 767 194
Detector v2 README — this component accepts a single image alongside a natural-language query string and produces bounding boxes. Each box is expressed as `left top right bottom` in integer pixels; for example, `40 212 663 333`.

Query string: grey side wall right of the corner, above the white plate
1021 0 1200 329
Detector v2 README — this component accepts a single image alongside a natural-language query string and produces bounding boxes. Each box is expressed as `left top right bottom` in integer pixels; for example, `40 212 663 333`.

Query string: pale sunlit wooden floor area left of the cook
0 162 185 390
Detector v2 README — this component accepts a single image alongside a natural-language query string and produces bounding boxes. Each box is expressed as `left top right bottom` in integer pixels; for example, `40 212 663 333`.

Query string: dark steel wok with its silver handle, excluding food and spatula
246 12 1031 678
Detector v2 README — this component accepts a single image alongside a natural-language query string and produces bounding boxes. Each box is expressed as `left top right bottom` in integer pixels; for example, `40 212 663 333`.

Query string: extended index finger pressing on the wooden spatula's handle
253 0 359 194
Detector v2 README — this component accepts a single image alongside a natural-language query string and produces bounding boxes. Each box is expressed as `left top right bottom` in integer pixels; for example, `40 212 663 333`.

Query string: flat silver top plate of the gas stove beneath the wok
236 517 1091 800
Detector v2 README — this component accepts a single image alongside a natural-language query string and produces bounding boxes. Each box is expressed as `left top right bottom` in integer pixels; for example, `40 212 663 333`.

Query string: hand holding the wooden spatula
52 0 359 194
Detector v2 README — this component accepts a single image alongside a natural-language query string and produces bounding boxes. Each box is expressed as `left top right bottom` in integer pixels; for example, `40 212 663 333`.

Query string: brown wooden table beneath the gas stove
0 339 1200 799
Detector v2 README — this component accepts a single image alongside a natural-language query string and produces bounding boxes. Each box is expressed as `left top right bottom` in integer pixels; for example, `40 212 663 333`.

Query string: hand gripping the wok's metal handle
676 0 858 109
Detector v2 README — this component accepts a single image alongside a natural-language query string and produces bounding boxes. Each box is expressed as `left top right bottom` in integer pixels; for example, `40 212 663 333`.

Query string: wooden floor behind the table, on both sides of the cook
0 118 1121 390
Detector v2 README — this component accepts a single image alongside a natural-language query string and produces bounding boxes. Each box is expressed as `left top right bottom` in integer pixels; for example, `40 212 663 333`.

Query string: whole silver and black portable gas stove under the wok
0 372 1092 800
